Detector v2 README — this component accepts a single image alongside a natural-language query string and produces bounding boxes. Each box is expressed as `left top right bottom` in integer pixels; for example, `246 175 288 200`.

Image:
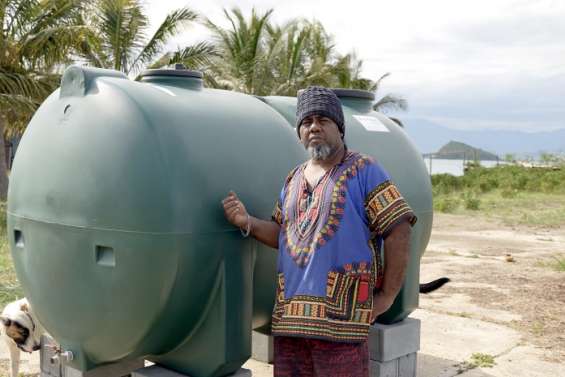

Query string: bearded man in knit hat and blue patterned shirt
223 87 416 377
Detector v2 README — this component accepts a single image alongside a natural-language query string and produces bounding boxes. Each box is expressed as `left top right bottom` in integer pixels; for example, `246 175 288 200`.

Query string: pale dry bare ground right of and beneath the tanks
0 214 565 377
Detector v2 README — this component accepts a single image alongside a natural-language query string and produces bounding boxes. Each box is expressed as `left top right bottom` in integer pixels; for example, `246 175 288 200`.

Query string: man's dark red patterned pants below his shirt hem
274 336 369 377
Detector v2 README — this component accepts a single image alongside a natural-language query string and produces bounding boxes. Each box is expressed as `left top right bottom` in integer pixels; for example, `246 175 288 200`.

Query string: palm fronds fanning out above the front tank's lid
77 0 215 74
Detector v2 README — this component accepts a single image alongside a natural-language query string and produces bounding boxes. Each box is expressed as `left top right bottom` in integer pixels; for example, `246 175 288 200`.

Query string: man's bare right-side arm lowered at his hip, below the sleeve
371 221 411 323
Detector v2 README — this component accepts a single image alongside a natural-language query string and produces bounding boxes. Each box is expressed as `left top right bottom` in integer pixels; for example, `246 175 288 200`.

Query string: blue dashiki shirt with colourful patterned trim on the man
272 152 416 343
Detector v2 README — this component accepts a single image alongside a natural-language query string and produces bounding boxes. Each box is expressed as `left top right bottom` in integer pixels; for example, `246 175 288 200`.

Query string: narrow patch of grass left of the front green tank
0 203 24 308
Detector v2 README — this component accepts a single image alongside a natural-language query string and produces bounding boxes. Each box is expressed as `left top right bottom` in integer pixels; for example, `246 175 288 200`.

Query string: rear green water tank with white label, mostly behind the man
262 89 433 324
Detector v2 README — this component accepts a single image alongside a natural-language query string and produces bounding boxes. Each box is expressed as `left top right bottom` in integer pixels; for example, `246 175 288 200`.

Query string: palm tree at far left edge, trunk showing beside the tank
0 0 93 200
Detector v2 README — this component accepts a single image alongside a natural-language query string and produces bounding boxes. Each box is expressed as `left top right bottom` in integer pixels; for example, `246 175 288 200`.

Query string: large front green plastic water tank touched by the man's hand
8 67 306 377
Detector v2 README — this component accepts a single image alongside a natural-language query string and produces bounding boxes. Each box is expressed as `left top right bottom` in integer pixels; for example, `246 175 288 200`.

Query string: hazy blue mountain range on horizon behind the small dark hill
399 116 565 156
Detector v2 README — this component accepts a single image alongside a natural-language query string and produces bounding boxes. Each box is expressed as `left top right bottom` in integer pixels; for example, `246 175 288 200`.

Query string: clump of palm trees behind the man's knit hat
205 8 407 115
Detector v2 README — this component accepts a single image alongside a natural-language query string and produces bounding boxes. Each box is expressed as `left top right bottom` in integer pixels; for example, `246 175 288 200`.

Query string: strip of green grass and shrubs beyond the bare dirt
432 166 565 227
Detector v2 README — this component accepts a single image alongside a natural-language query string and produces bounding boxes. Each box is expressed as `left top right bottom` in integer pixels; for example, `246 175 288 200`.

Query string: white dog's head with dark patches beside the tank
0 300 40 352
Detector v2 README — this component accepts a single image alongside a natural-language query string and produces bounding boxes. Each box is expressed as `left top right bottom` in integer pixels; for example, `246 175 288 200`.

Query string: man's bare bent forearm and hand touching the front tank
222 191 281 249
